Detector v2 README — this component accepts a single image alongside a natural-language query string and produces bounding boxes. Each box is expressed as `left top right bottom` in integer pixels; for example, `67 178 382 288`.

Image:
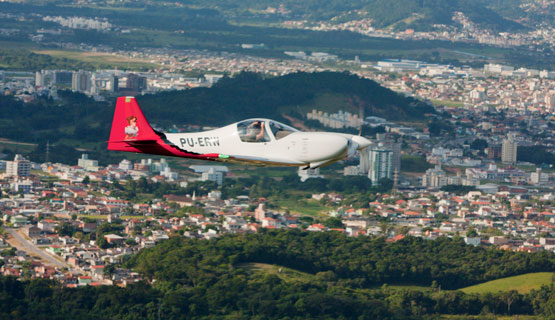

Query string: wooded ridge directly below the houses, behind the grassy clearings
129 231 555 289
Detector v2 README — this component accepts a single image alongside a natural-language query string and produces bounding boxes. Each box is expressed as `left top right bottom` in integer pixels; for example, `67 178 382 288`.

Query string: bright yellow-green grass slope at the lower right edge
461 272 553 293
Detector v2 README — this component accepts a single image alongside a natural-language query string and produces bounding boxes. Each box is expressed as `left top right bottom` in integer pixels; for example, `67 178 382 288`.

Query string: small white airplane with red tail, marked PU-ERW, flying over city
108 97 371 169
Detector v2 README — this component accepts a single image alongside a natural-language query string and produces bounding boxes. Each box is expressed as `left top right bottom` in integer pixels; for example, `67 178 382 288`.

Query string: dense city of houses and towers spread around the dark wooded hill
0 42 555 286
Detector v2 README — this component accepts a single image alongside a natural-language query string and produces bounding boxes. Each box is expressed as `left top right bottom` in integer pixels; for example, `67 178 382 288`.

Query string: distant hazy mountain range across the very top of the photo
22 0 555 32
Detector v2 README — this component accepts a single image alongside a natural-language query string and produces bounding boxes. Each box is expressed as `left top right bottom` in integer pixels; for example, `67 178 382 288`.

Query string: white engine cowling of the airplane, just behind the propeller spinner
301 133 349 162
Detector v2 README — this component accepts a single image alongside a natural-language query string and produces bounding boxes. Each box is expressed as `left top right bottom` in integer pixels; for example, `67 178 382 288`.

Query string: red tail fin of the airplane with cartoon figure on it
108 97 160 152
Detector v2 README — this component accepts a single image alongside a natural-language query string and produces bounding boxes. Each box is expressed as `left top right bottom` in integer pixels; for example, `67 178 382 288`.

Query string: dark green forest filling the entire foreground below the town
0 230 555 319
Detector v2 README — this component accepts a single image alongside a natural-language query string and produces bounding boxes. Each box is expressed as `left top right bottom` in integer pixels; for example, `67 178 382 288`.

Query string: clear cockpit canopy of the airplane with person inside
237 119 299 142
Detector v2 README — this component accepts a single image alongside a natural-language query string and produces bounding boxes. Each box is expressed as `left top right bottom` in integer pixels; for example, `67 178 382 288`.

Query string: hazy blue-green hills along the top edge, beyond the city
3 0 536 32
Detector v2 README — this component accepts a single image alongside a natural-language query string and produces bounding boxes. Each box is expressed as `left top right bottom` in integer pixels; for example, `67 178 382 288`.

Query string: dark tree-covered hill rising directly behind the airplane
138 72 435 125
